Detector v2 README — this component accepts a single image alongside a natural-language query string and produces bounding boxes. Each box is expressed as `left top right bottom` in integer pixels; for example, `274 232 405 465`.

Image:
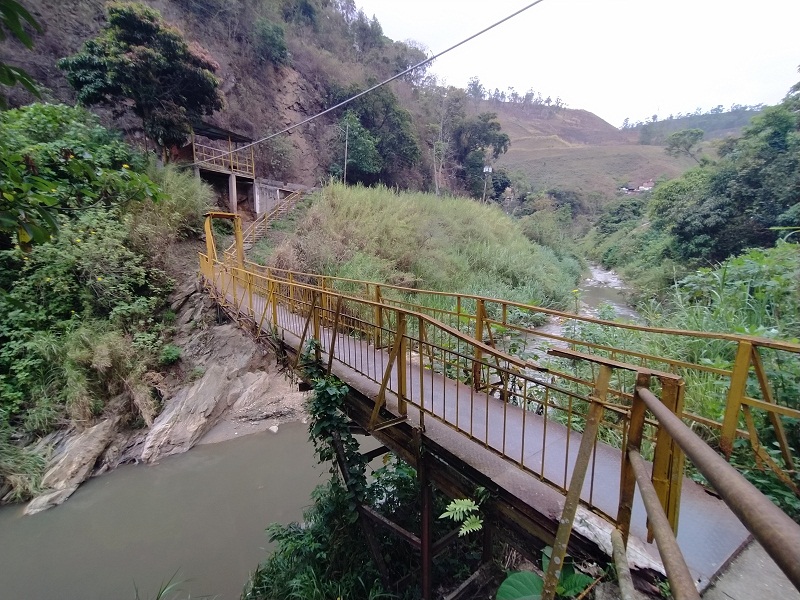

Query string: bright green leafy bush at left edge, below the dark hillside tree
0 104 157 247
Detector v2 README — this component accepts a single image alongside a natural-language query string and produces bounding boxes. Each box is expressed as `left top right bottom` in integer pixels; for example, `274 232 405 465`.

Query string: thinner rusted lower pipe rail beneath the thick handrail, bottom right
628 450 700 600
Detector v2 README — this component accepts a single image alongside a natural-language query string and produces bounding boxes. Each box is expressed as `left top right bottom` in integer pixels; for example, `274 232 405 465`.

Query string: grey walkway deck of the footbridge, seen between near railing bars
214 260 749 589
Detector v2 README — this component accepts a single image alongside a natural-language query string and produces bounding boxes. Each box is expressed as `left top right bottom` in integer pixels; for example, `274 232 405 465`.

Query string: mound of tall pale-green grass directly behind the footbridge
262 184 581 307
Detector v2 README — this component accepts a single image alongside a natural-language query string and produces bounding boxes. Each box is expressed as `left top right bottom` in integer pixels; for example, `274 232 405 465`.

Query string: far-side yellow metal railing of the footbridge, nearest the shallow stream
245 262 800 494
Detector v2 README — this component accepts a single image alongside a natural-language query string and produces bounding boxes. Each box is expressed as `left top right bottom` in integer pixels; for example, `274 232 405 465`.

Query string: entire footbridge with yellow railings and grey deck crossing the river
200 212 800 597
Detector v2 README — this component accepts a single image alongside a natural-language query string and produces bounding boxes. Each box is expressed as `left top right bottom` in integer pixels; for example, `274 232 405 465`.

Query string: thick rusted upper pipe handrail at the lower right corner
640 390 800 589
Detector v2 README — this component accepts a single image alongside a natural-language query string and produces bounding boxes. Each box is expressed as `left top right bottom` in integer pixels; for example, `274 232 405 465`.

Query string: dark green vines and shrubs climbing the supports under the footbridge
243 341 488 600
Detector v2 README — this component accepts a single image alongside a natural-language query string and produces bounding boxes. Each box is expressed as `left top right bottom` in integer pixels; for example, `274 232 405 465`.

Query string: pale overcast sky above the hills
356 0 800 126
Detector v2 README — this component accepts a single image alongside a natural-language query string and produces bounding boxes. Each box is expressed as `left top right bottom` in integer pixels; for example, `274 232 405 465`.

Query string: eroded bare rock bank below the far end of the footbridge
25 244 305 514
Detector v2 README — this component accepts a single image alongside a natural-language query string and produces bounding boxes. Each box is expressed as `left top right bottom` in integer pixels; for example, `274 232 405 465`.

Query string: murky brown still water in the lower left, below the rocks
0 423 328 600
